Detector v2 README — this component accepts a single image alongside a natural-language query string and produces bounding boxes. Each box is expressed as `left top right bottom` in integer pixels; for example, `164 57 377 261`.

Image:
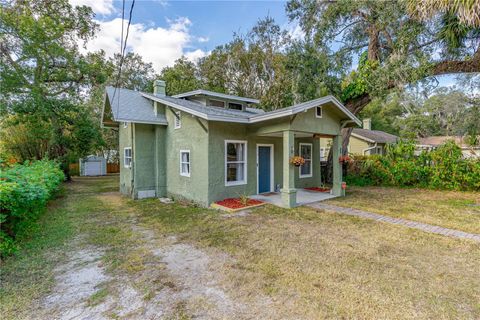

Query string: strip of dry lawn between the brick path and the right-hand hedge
326 187 480 234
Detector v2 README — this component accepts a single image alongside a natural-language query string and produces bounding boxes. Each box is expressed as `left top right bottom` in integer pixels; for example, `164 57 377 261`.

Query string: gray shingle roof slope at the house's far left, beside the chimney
106 87 167 125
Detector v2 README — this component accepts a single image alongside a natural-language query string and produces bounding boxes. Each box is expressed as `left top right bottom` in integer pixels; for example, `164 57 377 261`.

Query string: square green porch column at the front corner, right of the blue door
280 130 297 208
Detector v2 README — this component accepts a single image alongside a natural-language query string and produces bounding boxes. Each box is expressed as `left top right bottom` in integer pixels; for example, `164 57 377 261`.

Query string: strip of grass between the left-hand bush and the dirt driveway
0 176 116 319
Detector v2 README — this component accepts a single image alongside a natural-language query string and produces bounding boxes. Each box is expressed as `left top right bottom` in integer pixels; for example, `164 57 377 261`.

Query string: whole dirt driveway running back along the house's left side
35 178 276 319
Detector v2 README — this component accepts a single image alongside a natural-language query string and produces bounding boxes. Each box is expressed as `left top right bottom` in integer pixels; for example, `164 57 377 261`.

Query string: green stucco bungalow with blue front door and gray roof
102 80 361 207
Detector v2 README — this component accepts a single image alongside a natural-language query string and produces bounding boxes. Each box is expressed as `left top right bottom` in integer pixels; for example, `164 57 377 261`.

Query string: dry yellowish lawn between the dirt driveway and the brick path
131 200 480 319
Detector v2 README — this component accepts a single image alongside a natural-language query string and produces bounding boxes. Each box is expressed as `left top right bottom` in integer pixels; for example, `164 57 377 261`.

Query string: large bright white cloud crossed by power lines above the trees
86 17 207 72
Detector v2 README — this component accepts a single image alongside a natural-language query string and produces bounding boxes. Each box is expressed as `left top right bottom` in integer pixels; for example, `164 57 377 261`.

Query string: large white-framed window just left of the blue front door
225 140 247 186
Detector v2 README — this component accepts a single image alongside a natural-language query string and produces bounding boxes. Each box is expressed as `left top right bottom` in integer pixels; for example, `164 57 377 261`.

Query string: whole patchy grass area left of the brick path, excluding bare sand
0 177 480 319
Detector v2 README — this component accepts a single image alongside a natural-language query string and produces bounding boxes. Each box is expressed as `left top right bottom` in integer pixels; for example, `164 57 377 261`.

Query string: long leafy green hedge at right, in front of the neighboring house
345 141 480 191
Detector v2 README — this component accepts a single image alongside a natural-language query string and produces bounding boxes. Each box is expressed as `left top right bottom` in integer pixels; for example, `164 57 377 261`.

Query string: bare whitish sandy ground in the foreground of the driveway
37 194 273 320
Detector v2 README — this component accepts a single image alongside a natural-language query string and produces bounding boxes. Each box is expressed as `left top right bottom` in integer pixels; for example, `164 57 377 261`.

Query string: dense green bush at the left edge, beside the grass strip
0 160 64 256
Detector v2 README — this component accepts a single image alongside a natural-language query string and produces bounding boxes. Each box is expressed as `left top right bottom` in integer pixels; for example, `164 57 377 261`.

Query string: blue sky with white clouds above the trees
69 0 466 90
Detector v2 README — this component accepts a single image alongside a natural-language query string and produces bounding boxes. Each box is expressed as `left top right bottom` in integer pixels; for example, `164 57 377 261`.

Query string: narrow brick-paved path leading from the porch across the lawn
307 202 480 242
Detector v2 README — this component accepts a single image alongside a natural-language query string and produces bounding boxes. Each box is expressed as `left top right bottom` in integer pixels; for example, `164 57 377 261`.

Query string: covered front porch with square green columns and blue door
251 127 343 208
